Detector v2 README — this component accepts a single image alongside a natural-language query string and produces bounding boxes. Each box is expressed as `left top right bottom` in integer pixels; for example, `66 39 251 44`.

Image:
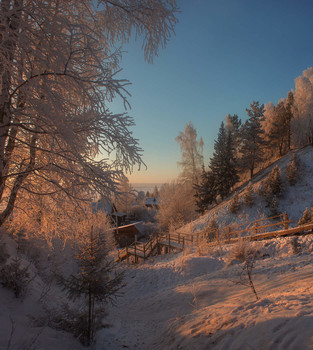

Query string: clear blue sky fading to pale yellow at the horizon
109 0 313 183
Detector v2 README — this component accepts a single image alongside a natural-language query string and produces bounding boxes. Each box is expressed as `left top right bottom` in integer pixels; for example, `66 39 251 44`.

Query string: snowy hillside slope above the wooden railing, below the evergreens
180 146 313 232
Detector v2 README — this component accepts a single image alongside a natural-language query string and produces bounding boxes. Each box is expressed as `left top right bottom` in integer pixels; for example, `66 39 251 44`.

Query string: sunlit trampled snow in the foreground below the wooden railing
97 235 313 350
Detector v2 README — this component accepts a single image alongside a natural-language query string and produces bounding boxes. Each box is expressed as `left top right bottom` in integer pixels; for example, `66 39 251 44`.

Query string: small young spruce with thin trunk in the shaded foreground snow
60 227 123 345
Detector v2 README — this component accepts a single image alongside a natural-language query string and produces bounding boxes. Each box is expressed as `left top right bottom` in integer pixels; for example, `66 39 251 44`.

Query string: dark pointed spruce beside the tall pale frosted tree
210 122 238 199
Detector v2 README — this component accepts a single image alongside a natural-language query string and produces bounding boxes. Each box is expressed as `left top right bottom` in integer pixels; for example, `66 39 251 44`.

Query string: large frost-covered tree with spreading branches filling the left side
0 0 177 226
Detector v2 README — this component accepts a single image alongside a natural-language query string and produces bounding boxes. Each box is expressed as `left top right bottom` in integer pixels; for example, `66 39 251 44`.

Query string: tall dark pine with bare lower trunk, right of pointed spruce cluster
241 101 265 178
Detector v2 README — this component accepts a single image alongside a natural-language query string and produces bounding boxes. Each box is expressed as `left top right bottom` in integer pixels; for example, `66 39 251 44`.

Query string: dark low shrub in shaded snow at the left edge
0 257 31 298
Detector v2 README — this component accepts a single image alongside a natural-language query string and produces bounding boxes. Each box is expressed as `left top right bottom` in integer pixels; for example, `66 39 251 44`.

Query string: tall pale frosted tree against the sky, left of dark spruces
175 122 203 184
